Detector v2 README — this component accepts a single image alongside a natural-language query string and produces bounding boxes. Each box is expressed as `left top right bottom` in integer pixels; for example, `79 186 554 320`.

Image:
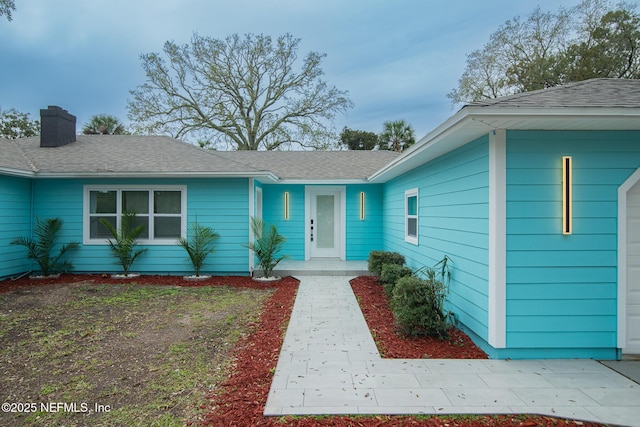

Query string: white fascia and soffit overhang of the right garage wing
369 106 640 183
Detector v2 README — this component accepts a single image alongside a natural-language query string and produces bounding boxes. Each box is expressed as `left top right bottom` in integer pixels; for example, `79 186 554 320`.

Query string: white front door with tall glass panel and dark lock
305 187 345 259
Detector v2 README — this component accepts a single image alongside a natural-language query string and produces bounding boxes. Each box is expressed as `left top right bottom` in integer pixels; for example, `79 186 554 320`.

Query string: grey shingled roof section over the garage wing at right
468 79 640 108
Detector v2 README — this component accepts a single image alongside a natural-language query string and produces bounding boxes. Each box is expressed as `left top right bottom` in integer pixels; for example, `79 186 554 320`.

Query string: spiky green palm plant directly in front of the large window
100 211 147 276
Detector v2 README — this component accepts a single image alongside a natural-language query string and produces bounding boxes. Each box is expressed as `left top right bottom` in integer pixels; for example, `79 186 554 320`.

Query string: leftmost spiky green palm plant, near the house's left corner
10 218 80 276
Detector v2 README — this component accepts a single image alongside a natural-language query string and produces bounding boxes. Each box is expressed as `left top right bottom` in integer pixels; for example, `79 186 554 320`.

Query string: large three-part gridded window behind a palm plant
85 187 186 243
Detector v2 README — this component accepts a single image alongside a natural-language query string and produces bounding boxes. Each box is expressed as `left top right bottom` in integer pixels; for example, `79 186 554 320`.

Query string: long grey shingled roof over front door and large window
0 135 398 180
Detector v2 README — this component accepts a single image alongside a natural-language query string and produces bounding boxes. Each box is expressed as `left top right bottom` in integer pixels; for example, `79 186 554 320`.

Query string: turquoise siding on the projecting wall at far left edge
0 176 32 279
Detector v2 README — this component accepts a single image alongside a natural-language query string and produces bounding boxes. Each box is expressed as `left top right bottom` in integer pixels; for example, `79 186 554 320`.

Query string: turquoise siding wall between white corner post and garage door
502 131 640 358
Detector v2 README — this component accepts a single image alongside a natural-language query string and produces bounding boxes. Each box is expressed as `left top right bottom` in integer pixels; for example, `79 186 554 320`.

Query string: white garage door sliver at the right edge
624 182 640 354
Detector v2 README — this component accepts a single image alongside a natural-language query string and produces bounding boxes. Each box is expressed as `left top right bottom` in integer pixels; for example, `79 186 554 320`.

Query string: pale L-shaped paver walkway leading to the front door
264 276 640 426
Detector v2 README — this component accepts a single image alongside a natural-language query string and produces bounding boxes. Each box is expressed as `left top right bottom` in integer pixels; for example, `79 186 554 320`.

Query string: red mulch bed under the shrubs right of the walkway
351 276 488 359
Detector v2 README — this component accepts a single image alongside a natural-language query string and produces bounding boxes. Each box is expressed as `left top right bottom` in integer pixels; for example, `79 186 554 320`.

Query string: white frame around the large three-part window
82 185 187 245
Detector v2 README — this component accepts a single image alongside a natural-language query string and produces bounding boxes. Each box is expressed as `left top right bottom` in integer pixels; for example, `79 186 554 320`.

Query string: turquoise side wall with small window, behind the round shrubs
383 137 489 340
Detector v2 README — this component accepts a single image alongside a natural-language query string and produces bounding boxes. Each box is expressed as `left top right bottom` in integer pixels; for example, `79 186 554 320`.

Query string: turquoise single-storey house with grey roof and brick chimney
0 79 640 359
